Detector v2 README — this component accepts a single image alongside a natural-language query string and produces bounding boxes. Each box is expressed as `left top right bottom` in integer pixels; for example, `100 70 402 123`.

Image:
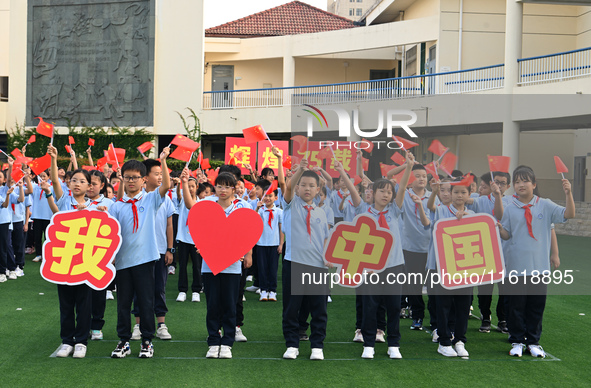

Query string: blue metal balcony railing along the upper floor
203 47 591 109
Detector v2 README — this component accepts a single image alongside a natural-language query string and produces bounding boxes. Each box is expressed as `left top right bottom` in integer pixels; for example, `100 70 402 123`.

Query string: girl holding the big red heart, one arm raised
181 168 252 358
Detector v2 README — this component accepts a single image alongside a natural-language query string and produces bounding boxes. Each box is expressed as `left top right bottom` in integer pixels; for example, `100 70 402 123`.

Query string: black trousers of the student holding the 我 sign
57 284 91 346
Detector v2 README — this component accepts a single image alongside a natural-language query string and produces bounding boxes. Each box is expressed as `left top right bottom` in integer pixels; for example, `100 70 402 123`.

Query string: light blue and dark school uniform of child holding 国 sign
425 204 474 346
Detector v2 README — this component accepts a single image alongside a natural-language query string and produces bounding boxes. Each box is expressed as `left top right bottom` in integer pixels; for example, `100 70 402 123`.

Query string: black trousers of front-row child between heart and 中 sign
282 260 328 349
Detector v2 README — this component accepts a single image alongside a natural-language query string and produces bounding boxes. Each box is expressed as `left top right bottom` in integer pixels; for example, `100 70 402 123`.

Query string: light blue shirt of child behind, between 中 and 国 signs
401 189 439 253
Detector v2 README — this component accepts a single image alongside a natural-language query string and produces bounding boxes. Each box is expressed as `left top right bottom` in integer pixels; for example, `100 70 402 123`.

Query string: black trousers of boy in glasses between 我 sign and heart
115 261 156 341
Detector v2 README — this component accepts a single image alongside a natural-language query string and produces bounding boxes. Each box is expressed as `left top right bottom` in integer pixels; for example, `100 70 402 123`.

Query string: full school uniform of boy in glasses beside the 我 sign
109 190 164 342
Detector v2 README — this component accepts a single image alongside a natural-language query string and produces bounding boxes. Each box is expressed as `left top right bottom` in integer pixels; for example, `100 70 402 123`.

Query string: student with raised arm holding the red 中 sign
357 151 415 359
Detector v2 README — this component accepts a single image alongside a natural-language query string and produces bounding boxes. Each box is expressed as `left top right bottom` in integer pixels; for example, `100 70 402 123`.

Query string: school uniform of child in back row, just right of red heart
256 205 283 292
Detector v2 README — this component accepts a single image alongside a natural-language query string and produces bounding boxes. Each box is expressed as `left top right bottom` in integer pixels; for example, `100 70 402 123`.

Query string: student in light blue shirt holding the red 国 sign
426 176 474 357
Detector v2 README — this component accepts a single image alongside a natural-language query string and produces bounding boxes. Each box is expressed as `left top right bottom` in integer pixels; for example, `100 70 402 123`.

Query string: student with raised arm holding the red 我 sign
41 144 96 358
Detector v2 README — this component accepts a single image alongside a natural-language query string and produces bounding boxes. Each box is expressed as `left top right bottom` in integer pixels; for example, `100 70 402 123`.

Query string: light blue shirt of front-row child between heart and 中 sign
282 195 329 268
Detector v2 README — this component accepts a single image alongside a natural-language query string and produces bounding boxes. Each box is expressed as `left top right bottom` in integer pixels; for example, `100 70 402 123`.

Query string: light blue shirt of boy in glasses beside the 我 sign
109 190 164 271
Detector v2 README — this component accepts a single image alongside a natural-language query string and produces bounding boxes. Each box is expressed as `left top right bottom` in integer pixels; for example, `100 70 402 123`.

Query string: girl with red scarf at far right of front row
499 166 575 358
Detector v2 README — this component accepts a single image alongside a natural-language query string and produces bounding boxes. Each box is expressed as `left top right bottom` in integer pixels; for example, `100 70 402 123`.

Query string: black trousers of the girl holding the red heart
203 272 241 346
